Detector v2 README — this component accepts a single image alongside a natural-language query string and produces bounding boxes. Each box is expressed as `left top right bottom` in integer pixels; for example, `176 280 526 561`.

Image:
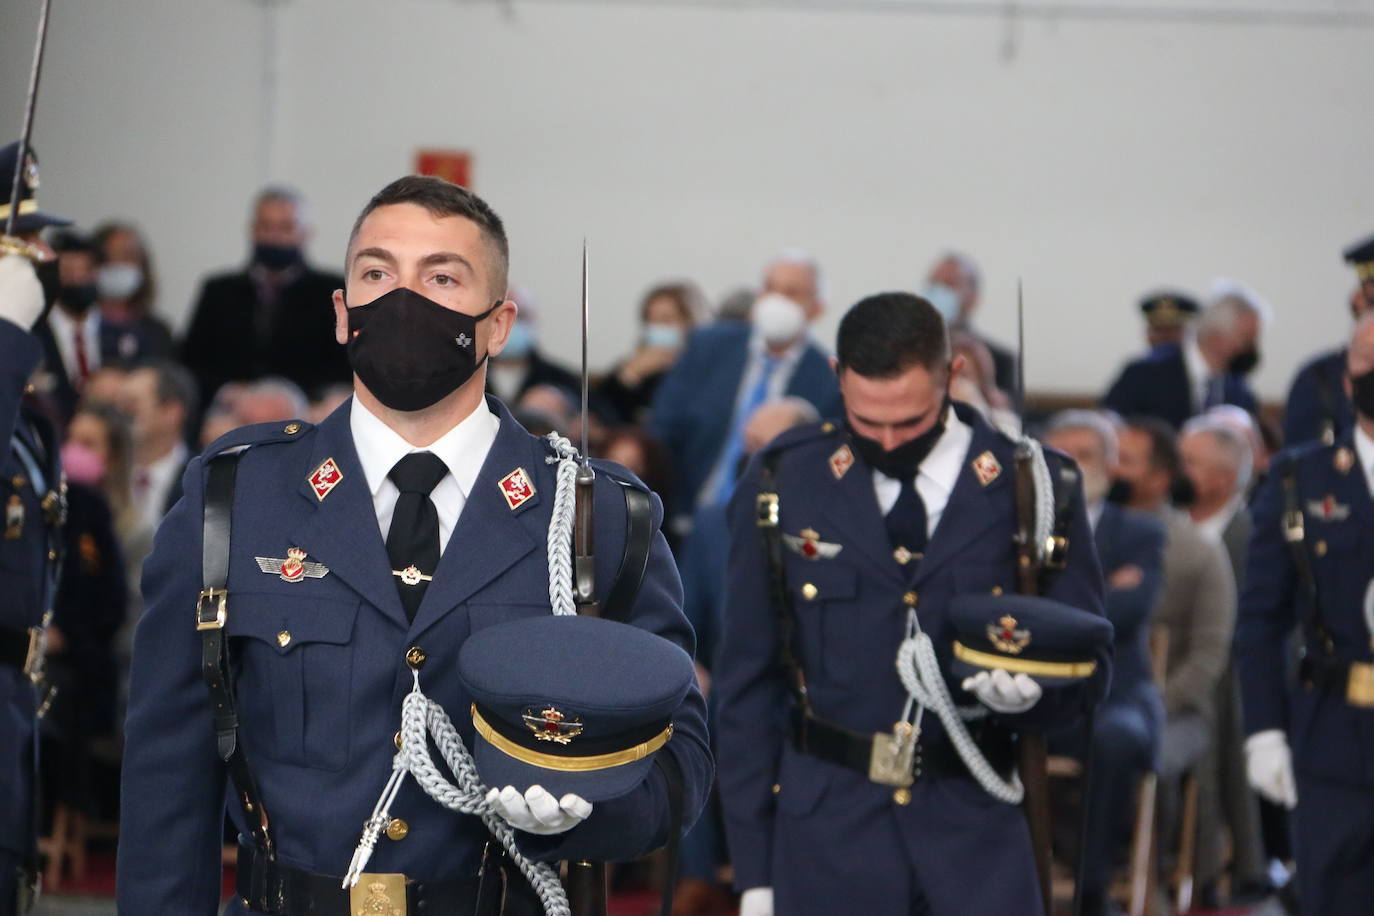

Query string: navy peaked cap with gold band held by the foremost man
458 615 697 802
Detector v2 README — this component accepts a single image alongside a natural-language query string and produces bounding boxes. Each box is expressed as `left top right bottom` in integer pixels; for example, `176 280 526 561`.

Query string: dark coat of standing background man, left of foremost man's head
181 266 353 404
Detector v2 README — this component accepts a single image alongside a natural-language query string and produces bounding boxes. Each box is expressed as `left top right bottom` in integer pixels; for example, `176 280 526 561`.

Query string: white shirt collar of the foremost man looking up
349 397 502 551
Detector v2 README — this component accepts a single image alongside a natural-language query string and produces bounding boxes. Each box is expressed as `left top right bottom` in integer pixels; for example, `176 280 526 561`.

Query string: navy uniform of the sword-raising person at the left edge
0 319 62 915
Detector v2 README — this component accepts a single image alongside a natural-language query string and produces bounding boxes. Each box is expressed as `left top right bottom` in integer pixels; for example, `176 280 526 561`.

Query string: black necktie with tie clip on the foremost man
386 452 448 621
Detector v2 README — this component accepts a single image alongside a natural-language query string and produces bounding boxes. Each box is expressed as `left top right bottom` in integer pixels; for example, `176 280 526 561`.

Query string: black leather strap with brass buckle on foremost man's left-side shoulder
195 452 276 867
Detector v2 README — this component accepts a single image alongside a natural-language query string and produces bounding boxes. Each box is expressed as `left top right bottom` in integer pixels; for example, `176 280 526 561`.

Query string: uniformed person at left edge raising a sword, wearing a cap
0 143 67 916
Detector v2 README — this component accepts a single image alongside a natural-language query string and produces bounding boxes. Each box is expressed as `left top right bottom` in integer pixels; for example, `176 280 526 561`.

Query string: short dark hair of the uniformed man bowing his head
835 293 949 379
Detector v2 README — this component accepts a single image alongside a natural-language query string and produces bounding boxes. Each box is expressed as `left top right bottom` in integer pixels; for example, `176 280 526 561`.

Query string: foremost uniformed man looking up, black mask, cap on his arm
118 176 710 916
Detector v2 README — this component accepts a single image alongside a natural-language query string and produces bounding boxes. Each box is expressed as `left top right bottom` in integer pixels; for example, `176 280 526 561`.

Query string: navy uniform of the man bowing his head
716 402 1110 916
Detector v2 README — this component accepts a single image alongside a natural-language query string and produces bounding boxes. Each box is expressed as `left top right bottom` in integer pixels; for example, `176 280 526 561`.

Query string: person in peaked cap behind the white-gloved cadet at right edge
1283 236 1374 445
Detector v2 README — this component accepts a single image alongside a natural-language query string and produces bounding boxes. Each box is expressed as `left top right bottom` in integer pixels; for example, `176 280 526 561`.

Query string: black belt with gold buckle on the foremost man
235 845 541 916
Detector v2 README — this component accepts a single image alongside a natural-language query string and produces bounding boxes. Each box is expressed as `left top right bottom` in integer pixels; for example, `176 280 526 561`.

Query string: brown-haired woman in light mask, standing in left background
91 222 173 361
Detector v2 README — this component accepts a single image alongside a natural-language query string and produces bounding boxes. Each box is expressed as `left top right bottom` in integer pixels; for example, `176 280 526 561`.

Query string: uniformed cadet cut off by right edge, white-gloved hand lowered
1235 314 1374 916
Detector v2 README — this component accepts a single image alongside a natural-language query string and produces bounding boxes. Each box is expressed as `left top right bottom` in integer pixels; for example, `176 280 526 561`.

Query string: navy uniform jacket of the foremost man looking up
118 400 712 915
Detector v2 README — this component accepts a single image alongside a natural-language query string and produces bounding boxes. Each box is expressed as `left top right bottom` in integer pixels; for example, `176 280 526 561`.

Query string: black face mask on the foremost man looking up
348 287 500 411
